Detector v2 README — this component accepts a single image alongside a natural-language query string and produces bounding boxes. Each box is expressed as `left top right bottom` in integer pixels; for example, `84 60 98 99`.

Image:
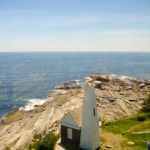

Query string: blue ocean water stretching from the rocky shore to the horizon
0 52 150 116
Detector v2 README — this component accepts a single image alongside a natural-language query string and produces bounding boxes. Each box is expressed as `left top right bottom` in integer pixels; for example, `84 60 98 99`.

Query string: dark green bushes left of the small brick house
29 132 59 150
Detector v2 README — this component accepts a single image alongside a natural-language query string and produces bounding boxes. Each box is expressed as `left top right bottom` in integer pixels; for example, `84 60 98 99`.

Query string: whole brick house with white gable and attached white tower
61 86 100 150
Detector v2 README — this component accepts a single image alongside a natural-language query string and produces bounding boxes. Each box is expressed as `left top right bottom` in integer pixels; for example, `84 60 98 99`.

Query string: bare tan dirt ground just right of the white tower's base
101 131 128 150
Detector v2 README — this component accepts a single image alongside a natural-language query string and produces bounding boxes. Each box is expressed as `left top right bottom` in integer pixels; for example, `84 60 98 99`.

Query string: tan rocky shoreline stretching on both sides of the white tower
0 74 150 150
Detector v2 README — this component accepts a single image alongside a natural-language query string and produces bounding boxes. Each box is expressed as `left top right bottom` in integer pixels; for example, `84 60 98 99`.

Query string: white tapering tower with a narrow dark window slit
80 86 100 150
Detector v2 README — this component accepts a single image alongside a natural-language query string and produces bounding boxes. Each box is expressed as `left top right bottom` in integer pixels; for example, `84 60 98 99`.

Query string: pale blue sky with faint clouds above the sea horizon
0 0 150 52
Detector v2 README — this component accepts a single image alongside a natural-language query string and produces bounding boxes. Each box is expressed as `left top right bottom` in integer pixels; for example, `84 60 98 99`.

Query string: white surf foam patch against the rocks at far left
19 99 46 111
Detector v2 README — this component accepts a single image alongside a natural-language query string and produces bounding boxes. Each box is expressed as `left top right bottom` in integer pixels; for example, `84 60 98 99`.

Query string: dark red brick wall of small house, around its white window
61 125 81 147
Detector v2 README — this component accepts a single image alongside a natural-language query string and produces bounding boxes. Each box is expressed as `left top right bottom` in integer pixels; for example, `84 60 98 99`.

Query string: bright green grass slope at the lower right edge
102 113 150 150
